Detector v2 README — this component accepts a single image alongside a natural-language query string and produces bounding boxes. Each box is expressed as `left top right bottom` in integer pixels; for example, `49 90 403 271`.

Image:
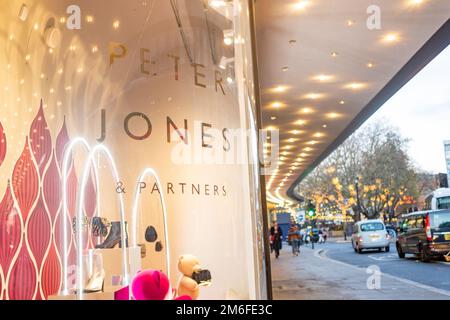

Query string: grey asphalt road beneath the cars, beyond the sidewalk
322 243 450 291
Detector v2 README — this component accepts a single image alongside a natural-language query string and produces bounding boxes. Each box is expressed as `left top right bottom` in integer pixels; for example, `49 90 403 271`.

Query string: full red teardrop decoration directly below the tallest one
27 195 52 271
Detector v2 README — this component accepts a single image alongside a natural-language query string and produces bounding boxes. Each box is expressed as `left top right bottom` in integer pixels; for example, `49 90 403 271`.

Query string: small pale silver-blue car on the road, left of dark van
352 219 389 253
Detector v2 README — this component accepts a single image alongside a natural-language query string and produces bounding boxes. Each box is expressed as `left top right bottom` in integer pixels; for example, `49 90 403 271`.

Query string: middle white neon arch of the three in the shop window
76 145 129 300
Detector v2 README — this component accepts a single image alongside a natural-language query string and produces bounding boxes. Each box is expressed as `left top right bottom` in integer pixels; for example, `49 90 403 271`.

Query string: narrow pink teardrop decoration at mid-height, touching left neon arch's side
44 153 61 224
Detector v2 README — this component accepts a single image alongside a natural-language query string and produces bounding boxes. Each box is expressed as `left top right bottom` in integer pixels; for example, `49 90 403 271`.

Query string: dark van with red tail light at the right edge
396 209 450 262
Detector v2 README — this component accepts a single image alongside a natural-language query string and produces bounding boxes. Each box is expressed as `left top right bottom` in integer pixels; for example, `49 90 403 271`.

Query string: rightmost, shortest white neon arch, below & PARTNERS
131 168 170 279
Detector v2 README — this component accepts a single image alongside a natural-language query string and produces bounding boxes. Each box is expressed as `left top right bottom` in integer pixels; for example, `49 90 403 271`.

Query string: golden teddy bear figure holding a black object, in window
177 254 211 300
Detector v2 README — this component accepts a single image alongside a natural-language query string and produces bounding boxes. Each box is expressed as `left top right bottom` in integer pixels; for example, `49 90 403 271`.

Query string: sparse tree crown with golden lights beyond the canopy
298 121 420 220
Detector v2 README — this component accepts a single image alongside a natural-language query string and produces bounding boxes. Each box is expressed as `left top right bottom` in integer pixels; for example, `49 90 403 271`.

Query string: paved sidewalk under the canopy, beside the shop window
272 246 450 300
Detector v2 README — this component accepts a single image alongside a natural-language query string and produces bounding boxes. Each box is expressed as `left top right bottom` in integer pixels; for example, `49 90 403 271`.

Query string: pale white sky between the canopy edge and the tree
368 46 450 173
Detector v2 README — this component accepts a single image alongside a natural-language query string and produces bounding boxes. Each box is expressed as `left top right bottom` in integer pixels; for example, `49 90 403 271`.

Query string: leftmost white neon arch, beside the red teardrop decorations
62 138 100 295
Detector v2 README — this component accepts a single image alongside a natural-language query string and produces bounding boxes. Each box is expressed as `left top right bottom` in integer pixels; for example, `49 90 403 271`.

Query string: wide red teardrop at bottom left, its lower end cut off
8 243 37 300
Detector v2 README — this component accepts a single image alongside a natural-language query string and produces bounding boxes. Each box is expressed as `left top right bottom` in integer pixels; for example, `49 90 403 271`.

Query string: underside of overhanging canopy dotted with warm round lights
256 0 450 203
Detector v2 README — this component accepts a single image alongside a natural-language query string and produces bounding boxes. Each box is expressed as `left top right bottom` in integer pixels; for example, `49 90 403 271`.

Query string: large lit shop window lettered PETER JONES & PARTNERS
0 0 267 299
